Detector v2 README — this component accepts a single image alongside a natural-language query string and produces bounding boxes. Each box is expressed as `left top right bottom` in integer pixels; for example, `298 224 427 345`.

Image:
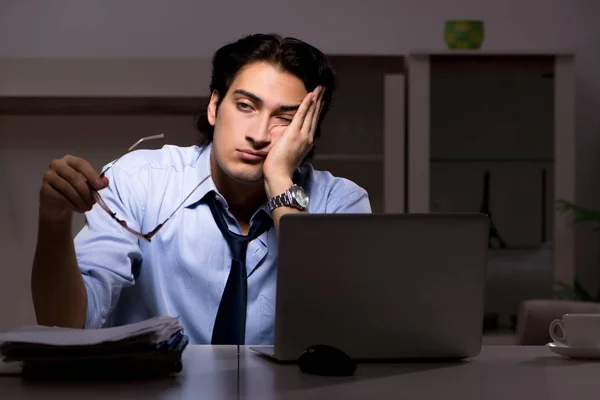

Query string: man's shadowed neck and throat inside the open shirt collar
211 153 266 225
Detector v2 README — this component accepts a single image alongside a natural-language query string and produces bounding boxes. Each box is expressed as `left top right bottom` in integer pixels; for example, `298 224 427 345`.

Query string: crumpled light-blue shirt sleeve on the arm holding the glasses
74 162 146 328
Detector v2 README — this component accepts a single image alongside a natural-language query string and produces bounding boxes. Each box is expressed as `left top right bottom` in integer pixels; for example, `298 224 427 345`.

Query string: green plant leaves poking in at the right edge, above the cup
553 199 600 302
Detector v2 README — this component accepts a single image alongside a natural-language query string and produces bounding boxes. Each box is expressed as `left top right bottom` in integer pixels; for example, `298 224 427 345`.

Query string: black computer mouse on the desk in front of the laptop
298 344 356 376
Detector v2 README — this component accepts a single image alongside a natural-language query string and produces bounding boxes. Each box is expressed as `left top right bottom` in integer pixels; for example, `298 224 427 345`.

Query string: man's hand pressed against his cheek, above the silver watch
263 86 325 198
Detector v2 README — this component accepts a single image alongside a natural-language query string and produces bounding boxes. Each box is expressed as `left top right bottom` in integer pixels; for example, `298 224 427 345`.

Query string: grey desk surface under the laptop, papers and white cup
0 346 600 400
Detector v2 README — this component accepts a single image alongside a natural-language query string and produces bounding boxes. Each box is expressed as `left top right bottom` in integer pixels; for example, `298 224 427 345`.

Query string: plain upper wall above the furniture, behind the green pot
0 0 584 57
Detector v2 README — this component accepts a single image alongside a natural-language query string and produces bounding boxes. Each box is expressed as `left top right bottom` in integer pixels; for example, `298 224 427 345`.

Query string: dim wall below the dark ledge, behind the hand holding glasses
0 115 195 331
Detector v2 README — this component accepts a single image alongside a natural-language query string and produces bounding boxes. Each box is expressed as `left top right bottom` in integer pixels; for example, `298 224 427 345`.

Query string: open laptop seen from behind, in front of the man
250 213 489 361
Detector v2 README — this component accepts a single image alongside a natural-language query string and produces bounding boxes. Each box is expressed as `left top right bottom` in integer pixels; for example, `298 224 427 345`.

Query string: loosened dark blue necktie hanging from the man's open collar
207 192 272 345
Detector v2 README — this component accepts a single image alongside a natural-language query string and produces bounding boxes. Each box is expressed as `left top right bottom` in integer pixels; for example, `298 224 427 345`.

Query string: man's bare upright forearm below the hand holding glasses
31 212 87 328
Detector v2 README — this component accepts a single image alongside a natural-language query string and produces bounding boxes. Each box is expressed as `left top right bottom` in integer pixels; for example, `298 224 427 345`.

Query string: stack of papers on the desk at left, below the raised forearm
0 317 188 379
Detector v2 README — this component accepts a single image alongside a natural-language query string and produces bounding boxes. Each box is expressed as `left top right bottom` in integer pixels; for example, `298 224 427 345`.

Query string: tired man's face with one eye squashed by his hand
208 62 308 183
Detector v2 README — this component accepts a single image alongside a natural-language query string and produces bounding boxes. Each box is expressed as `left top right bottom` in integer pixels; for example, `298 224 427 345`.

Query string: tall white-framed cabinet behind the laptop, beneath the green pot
405 52 575 311
